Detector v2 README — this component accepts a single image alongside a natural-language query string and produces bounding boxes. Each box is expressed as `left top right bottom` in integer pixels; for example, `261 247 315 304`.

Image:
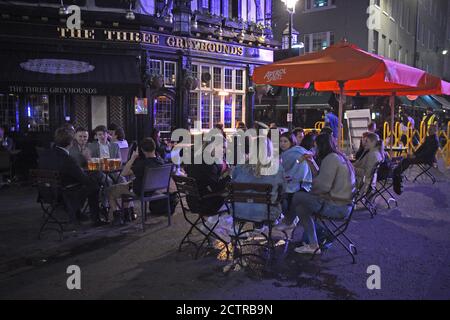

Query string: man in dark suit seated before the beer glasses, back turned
39 128 102 226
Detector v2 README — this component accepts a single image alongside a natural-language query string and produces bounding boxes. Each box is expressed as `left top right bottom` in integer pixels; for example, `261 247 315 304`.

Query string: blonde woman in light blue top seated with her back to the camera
232 141 286 223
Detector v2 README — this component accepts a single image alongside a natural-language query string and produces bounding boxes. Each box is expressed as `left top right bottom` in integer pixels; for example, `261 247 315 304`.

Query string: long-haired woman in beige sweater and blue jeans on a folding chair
279 134 355 254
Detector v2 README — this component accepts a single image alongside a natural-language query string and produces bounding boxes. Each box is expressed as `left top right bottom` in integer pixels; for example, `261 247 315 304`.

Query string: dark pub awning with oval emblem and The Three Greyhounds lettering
0 52 142 95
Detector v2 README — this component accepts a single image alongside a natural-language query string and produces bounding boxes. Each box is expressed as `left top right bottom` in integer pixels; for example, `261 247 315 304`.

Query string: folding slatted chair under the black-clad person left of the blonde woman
173 176 230 259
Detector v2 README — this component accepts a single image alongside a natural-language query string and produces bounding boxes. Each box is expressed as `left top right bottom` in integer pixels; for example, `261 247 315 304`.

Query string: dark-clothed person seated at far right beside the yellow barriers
394 124 439 194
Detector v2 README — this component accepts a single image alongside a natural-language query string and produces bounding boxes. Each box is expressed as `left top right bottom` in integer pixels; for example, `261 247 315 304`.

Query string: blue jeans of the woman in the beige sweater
289 192 352 245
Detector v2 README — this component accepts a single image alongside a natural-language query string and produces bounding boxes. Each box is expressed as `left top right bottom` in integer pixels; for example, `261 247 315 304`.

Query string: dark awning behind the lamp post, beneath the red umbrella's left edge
255 87 333 109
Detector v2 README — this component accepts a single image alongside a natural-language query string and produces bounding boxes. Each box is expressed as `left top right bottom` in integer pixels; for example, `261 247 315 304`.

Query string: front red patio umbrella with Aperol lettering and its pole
253 41 437 144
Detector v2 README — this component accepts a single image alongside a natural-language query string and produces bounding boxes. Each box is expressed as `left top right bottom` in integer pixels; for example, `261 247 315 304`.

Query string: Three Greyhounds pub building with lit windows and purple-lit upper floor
0 0 279 152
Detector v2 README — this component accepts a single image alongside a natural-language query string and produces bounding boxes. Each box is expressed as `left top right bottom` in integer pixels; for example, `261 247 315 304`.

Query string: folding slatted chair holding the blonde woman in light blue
228 183 288 267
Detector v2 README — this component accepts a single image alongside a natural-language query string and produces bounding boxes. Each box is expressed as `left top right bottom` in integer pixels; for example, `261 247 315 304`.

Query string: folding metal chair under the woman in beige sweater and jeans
311 190 359 264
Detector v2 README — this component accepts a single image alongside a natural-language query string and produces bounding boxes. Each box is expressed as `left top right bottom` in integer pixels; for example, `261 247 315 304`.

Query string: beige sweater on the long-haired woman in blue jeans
312 153 355 205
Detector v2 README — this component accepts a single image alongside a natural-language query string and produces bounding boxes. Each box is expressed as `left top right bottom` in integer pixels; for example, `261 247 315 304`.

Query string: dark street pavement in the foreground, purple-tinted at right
0 166 450 300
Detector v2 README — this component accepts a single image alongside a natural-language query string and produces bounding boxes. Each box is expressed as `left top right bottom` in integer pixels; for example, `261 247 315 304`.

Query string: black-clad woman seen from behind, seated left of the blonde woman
184 143 230 215
